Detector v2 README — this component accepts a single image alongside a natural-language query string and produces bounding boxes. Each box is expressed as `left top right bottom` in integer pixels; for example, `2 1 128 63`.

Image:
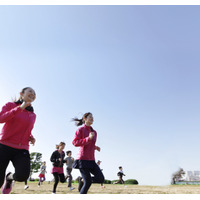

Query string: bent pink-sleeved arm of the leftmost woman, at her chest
0 103 22 123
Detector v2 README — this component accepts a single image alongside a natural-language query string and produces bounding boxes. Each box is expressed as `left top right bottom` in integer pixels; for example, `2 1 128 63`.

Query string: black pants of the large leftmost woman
0 144 30 187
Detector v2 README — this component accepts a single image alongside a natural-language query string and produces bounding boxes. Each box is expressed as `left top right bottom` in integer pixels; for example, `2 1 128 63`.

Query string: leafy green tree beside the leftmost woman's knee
30 152 42 179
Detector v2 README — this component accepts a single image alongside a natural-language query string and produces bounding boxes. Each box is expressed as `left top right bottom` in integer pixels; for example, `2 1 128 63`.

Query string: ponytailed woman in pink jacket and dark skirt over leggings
72 112 104 194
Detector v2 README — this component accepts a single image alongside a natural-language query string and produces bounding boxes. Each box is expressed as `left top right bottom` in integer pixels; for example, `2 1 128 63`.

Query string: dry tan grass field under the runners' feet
11 182 200 194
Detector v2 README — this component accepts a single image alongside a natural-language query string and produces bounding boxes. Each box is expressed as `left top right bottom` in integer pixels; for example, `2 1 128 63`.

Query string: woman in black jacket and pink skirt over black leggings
50 142 66 194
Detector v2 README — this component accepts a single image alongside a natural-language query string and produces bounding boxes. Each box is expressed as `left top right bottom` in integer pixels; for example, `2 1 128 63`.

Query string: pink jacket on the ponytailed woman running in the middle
72 125 97 160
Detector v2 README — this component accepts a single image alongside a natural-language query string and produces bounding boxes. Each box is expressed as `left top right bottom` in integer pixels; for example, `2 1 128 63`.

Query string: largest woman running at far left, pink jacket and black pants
0 87 36 194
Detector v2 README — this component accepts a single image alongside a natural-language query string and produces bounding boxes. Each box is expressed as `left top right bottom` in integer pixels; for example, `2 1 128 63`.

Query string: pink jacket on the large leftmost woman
0 102 36 150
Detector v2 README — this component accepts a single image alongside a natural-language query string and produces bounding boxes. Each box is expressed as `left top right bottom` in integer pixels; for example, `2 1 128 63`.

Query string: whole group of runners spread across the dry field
0 87 124 194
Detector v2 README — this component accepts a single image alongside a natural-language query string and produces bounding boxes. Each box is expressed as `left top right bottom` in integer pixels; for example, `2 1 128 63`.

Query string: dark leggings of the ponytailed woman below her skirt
79 163 104 194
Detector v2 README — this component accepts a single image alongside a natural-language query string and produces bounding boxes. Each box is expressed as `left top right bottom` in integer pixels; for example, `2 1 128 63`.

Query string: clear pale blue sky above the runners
0 6 200 185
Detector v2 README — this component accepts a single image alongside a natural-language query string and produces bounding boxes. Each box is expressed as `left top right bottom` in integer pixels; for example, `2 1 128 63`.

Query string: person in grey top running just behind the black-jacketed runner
65 151 75 191
